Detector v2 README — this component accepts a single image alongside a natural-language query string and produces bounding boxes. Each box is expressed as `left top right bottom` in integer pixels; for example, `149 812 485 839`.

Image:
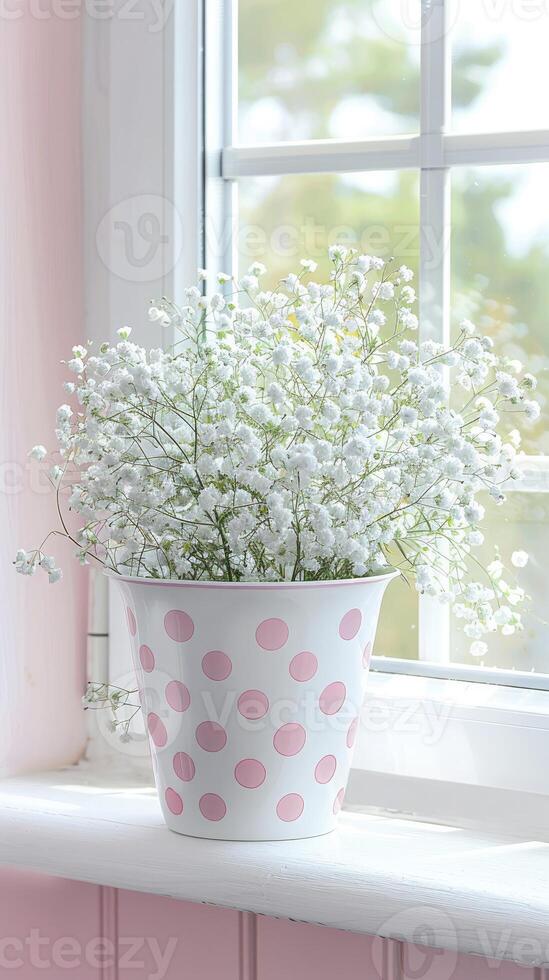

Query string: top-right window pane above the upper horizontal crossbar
450 0 549 132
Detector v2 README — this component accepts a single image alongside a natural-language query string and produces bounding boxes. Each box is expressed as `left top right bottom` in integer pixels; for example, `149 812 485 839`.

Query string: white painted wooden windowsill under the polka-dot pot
0 765 549 965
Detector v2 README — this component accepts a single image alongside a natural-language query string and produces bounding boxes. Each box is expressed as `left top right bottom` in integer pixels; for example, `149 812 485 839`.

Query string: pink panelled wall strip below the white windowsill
0 871 540 980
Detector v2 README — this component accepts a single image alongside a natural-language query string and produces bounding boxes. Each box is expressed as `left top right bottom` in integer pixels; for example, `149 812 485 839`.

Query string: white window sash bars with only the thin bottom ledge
205 0 549 690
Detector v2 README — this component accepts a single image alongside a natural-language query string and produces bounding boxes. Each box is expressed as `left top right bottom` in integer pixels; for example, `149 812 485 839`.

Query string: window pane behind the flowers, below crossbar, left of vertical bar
239 172 419 659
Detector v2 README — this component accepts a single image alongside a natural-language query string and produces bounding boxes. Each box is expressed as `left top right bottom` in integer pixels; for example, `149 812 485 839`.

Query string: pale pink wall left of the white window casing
0 0 86 774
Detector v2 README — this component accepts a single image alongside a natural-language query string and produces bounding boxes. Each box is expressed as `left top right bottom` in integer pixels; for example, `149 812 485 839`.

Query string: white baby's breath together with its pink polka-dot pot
16 246 539 839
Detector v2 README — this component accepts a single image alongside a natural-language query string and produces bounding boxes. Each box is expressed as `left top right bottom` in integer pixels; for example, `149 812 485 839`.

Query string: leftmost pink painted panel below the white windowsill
0 869 101 980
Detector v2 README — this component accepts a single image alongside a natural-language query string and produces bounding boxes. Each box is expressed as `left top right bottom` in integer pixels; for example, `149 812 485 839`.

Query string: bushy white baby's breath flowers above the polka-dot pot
18 246 539 654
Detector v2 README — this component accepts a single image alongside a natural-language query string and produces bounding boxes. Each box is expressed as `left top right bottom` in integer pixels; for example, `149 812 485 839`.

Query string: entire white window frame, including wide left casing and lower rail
83 0 549 826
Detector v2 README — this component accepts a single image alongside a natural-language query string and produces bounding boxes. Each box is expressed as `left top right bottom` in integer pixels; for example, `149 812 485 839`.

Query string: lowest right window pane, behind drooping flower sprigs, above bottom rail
452 492 549 674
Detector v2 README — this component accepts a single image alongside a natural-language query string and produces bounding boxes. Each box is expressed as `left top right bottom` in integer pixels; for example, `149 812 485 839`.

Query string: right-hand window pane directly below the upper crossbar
452 164 549 454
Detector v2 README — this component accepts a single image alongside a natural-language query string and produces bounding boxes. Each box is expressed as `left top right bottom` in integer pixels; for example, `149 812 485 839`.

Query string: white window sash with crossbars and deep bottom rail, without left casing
199 0 549 816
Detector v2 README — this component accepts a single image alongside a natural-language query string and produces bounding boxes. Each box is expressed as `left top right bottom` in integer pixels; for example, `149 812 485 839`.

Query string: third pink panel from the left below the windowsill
257 918 379 980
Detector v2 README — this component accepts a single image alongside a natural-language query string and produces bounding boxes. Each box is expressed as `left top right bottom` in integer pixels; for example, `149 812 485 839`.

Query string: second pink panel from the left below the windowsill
118 888 240 980
